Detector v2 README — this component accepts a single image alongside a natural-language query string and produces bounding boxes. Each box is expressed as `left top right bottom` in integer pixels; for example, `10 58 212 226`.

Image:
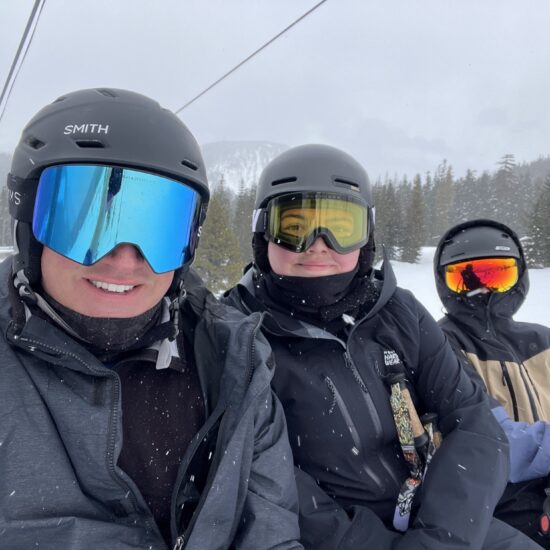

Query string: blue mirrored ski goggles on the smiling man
32 164 202 273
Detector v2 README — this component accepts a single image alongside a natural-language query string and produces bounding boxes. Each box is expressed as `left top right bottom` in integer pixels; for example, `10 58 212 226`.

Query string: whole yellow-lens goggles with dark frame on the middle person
253 193 369 254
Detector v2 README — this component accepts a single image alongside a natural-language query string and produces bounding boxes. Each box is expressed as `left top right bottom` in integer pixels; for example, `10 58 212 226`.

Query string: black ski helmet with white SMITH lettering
8 88 209 285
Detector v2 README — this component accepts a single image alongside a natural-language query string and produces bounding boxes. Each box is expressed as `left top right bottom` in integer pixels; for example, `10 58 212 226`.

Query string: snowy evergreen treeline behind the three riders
0 153 550 292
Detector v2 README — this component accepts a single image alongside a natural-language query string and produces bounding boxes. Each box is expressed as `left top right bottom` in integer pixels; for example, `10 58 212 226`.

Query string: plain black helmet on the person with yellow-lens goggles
252 144 374 273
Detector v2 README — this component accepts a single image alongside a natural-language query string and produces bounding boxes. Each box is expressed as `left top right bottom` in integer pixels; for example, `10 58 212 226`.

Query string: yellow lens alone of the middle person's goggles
268 197 368 249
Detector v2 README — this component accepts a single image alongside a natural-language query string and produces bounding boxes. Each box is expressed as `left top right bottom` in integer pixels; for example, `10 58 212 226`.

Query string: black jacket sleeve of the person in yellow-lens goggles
405 300 509 549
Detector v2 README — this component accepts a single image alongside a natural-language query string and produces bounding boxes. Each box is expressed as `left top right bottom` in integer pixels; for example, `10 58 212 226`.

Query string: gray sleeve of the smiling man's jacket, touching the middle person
235 390 303 550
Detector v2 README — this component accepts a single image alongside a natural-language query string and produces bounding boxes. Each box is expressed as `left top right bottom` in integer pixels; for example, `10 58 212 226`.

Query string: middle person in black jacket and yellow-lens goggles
225 145 538 550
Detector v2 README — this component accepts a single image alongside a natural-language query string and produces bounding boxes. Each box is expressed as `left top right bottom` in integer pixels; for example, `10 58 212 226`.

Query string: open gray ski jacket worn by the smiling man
0 260 302 550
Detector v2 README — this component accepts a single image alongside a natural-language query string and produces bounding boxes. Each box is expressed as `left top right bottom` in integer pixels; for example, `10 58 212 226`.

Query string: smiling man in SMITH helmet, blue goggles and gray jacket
0 89 301 550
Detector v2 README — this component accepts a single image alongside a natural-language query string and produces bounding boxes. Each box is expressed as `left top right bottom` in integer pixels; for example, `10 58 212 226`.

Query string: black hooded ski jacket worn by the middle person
226 263 508 550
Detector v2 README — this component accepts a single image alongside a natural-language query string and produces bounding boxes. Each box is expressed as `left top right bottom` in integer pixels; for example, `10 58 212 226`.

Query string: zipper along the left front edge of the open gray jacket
14 337 157 544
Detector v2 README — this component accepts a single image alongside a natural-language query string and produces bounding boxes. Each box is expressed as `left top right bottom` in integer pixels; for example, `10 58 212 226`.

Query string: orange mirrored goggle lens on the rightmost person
445 258 518 293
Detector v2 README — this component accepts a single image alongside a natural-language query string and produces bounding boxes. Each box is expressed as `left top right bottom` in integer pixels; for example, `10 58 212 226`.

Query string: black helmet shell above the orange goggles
438 220 523 267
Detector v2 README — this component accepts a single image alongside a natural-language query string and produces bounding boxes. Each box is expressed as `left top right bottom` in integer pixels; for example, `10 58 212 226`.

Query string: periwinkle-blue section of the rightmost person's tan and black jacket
493 405 550 483
